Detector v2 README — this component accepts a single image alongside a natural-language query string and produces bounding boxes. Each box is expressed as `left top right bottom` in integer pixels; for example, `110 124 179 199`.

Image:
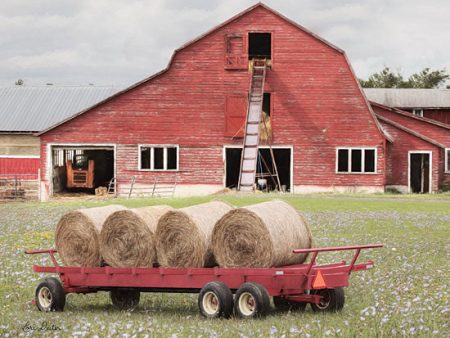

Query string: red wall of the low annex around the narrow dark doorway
382 123 443 192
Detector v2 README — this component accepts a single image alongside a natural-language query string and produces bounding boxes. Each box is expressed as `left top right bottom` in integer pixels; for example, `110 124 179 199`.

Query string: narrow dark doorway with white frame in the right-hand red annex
409 153 430 194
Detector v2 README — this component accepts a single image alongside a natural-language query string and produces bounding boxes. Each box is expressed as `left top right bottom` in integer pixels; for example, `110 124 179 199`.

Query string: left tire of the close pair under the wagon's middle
198 282 233 318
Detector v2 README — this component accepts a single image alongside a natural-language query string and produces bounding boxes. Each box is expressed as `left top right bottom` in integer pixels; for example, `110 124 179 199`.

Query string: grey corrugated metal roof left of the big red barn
0 86 123 132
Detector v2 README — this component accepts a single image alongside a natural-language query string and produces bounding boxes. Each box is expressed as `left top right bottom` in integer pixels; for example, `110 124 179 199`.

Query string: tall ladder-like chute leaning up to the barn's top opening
238 59 280 191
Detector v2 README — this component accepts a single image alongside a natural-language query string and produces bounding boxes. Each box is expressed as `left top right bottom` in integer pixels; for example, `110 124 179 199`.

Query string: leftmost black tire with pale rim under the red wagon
35 277 66 312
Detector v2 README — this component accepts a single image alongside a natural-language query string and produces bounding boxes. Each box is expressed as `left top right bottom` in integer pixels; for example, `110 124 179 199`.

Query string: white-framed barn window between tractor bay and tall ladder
139 145 178 171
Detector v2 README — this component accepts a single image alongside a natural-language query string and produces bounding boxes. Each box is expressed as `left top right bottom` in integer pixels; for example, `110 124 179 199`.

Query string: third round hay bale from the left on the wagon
155 201 232 268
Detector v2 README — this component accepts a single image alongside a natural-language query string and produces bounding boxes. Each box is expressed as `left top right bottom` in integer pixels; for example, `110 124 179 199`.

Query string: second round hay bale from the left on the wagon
100 205 173 267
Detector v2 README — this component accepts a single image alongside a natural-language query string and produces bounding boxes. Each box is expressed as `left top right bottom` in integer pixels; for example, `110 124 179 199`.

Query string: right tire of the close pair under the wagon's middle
234 282 270 318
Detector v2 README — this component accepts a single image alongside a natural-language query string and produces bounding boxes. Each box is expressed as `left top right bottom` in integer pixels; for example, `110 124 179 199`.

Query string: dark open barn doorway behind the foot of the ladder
225 146 292 192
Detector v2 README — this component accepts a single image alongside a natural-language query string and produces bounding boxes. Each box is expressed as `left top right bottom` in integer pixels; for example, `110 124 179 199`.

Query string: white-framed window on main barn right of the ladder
336 148 376 174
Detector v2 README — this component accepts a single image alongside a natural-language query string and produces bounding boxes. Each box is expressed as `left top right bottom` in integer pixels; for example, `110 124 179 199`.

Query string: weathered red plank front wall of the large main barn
41 7 385 198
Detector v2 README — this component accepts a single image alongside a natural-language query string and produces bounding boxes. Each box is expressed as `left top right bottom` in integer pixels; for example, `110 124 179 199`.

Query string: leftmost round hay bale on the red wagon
55 205 126 266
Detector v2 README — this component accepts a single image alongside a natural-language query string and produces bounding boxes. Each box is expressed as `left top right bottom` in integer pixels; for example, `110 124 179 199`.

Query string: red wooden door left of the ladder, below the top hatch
225 96 247 137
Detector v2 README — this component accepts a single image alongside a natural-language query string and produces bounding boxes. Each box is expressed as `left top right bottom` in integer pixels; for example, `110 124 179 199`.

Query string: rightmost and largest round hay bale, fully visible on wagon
212 201 312 268
